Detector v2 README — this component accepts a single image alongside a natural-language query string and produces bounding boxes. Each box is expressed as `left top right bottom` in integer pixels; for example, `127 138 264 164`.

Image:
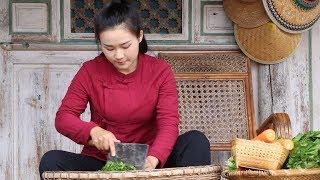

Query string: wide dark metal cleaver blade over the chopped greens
107 143 149 170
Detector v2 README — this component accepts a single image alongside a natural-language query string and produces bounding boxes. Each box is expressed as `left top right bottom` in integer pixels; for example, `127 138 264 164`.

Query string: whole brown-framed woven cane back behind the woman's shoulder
159 52 254 150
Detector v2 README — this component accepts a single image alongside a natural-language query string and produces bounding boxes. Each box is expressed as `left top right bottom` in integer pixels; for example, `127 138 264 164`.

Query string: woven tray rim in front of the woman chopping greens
42 165 221 180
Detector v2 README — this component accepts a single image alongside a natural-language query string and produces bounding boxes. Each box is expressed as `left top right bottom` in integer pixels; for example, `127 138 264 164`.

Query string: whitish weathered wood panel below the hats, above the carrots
259 33 310 135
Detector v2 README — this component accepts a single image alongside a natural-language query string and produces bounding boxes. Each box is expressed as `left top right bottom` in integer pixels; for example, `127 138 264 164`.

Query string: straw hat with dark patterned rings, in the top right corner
263 0 320 33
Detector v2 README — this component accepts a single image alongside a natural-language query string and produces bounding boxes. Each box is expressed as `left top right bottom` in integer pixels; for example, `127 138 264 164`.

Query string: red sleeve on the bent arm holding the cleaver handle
55 64 97 144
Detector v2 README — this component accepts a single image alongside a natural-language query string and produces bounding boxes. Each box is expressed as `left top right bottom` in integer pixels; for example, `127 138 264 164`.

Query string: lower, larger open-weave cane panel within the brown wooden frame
177 80 248 144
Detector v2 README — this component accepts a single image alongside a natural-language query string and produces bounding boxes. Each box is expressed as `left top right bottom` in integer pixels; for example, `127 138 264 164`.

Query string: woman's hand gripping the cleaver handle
89 126 120 156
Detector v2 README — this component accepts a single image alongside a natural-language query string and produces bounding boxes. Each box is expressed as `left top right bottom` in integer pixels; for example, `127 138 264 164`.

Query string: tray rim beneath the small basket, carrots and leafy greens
222 168 320 180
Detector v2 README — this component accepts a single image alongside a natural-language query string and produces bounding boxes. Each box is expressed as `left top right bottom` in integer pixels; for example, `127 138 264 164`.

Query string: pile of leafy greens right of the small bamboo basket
286 131 320 169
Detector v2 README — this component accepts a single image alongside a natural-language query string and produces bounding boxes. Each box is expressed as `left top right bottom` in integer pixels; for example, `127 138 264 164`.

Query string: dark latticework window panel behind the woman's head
70 0 182 34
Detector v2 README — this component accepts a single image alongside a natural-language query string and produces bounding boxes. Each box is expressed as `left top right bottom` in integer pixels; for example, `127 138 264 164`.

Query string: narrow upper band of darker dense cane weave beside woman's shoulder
161 53 248 73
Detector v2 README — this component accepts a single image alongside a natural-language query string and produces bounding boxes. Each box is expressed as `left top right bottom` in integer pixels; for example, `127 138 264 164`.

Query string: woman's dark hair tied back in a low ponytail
95 0 148 53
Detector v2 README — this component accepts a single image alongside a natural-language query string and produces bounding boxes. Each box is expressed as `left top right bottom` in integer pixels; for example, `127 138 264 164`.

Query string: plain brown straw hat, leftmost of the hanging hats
223 0 270 28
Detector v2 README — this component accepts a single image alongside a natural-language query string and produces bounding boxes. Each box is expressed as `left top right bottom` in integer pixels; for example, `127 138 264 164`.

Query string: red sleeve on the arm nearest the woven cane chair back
149 67 179 167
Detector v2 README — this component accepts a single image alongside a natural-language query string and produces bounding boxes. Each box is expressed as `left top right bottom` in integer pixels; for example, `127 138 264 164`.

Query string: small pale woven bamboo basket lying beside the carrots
231 138 289 170
